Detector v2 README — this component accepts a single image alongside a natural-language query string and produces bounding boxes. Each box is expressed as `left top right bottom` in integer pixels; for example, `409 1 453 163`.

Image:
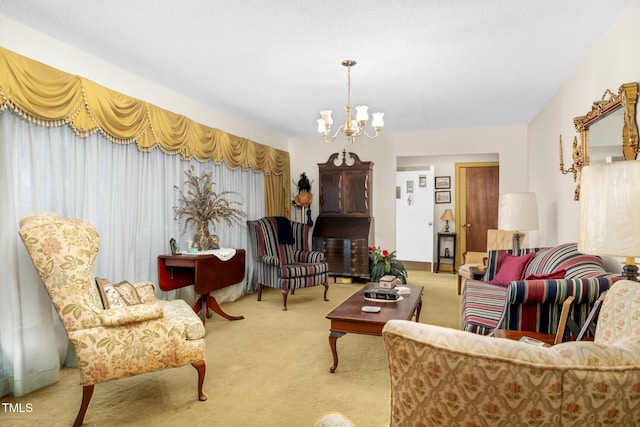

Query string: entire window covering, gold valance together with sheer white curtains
0 48 282 396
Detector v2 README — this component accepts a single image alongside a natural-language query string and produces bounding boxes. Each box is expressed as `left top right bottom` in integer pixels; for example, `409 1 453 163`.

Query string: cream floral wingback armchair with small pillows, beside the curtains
19 212 206 426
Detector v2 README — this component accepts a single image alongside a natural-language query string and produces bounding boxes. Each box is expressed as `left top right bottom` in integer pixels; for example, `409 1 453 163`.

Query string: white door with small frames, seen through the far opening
396 166 434 266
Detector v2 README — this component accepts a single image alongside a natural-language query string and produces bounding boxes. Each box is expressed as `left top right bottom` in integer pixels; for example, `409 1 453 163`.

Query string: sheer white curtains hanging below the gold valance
0 111 265 396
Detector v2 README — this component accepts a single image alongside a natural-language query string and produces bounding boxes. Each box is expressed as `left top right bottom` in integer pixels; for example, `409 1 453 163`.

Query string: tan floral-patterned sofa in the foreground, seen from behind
382 280 640 427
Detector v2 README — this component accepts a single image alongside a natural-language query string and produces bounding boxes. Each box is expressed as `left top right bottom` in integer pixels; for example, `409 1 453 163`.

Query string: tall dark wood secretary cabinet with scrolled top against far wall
312 152 374 279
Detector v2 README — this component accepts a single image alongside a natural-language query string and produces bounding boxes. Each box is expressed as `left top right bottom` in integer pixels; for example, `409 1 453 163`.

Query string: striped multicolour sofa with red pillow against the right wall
462 243 621 335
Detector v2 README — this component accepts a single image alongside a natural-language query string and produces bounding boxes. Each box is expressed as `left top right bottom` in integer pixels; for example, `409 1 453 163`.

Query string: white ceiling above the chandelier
0 0 632 137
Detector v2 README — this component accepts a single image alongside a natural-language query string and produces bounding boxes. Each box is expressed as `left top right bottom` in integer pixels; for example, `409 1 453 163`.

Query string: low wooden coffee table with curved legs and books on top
326 285 423 373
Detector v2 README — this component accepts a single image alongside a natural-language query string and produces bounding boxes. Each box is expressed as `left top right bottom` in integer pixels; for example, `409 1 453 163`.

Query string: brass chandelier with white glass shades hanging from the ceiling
318 59 384 142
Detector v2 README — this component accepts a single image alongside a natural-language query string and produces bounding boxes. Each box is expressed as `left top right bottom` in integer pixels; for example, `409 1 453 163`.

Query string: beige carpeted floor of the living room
0 270 460 427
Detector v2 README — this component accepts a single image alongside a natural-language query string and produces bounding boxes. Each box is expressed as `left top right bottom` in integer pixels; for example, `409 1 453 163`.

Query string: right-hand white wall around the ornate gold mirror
527 0 640 244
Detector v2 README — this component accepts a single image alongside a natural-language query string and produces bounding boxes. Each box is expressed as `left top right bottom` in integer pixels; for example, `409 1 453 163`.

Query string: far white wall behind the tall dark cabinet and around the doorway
289 124 527 250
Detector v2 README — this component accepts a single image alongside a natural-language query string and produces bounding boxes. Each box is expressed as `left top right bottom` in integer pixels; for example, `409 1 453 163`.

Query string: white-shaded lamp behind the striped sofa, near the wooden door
498 193 538 251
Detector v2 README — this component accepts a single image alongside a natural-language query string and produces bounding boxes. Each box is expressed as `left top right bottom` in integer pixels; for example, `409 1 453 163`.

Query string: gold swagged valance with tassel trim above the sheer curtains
0 48 290 216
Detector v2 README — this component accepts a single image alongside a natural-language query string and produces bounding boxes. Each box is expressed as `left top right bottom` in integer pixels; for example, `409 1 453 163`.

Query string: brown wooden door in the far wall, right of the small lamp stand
456 162 500 259
